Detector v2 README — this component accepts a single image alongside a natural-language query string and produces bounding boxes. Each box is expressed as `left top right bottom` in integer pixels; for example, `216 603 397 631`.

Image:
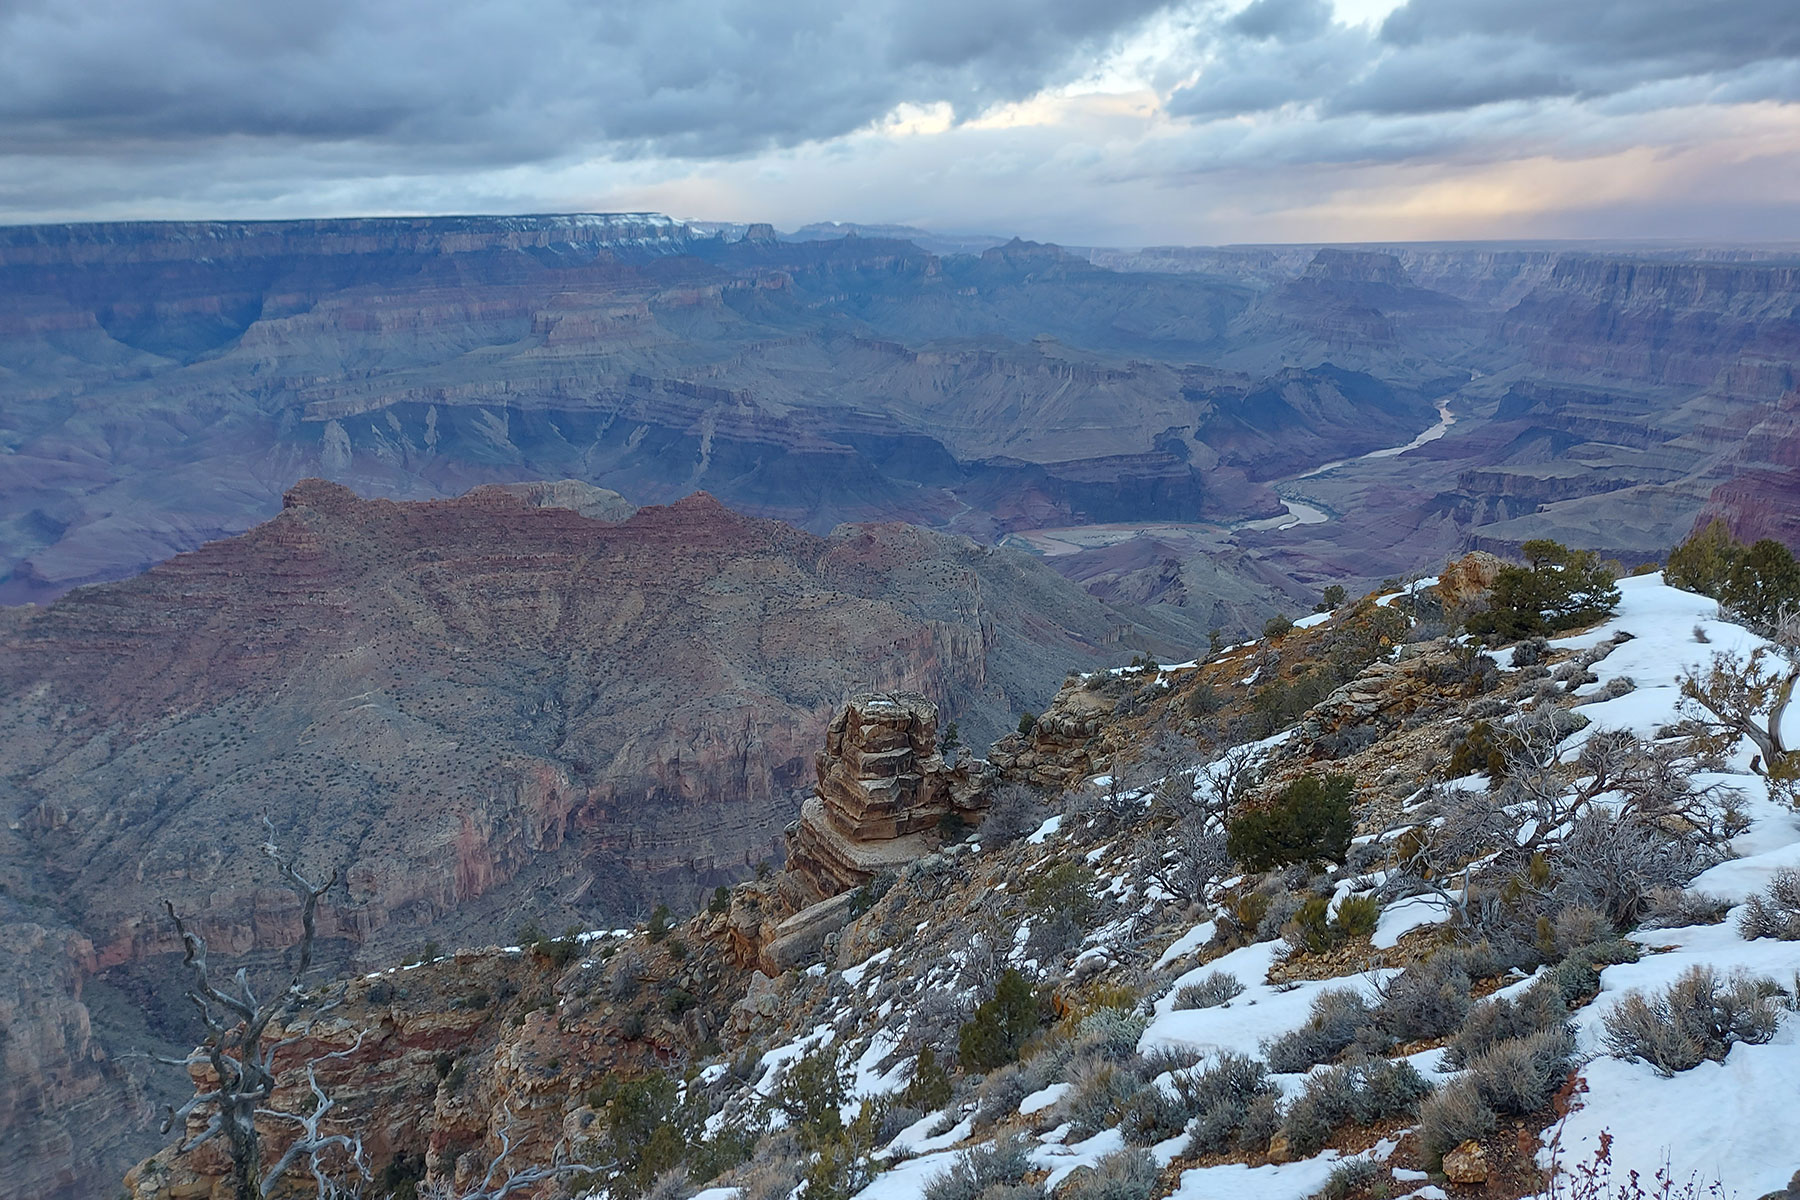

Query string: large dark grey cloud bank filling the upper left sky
0 0 1157 164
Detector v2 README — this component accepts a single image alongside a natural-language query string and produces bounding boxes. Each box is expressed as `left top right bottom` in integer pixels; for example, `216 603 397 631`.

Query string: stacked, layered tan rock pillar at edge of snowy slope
788 693 992 896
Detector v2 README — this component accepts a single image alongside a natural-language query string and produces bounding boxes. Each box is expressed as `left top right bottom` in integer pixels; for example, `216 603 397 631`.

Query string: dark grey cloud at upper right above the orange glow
1170 0 1800 119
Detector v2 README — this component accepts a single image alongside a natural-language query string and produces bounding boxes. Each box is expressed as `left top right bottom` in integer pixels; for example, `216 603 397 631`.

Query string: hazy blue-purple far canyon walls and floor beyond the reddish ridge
0 214 1800 630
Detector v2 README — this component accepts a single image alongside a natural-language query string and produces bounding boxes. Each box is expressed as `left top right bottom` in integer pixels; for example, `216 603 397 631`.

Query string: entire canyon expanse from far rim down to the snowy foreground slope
10 214 1800 1200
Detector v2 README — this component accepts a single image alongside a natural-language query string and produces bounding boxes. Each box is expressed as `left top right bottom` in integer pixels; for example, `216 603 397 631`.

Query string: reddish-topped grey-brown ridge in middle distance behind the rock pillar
0 480 1199 1196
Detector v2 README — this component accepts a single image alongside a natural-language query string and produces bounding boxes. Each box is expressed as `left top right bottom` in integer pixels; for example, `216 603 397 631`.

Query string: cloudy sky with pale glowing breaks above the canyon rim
0 0 1800 246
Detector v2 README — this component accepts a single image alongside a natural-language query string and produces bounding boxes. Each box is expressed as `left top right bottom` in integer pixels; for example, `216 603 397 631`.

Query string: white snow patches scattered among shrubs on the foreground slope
842 576 1800 1200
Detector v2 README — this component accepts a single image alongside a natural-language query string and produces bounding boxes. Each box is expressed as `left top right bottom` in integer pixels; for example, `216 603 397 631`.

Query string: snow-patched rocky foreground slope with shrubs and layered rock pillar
128 560 1800 1200
